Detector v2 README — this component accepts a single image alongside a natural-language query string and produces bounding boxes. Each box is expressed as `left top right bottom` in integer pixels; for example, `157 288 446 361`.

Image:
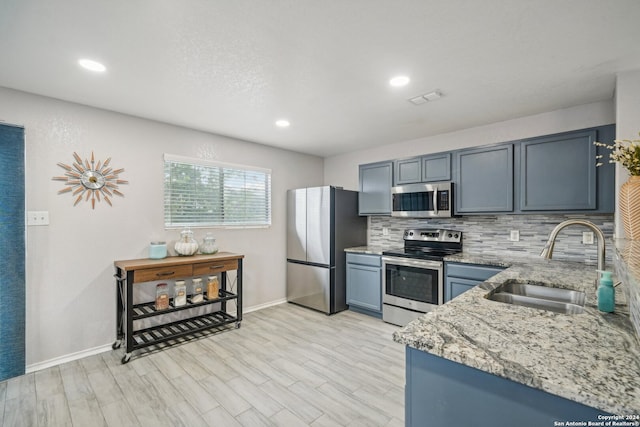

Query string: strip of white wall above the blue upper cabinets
324 100 616 190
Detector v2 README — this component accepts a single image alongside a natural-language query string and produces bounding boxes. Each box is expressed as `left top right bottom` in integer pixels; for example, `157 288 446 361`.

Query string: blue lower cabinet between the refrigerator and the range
347 253 382 317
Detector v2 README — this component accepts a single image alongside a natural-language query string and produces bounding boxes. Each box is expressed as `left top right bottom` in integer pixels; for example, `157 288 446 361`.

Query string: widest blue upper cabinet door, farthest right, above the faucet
519 130 597 211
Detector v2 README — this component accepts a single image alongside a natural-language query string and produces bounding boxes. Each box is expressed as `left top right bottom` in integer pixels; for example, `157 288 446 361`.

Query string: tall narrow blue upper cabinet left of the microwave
358 161 393 215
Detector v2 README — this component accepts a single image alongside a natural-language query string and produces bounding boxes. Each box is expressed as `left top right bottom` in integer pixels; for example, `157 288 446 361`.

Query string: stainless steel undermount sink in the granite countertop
487 282 585 314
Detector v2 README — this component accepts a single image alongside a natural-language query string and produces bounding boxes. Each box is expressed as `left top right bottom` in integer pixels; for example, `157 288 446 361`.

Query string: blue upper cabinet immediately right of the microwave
454 144 513 214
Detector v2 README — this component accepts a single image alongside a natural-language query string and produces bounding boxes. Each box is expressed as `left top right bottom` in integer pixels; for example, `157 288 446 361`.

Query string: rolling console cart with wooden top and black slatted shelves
112 252 244 363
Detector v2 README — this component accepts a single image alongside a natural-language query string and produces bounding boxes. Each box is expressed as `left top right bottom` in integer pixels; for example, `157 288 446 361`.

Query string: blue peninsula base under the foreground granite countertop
405 347 606 427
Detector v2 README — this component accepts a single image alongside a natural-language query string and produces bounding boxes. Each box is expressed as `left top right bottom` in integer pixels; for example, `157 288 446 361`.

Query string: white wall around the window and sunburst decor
0 88 323 366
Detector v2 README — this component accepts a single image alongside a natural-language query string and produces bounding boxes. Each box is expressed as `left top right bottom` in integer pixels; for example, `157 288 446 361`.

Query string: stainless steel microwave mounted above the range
391 182 453 218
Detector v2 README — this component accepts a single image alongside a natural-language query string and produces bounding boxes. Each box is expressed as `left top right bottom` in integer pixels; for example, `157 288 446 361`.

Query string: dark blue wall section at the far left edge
0 124 25 381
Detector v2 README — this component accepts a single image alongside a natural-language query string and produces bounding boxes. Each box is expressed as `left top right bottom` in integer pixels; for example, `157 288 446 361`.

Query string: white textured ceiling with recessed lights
0 0 640 156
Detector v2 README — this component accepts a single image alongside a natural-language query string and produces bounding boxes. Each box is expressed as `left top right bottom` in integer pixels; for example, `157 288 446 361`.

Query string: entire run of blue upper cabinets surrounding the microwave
360 124 616 215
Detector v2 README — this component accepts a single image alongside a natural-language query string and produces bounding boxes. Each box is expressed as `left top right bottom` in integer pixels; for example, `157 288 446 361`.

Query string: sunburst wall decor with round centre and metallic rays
53 151 129 209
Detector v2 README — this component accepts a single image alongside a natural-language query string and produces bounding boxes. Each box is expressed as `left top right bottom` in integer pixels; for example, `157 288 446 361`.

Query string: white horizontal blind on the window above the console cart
164 154 271 227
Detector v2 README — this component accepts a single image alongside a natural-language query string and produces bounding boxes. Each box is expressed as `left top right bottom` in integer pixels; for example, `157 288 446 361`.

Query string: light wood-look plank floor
0 304 404 427
